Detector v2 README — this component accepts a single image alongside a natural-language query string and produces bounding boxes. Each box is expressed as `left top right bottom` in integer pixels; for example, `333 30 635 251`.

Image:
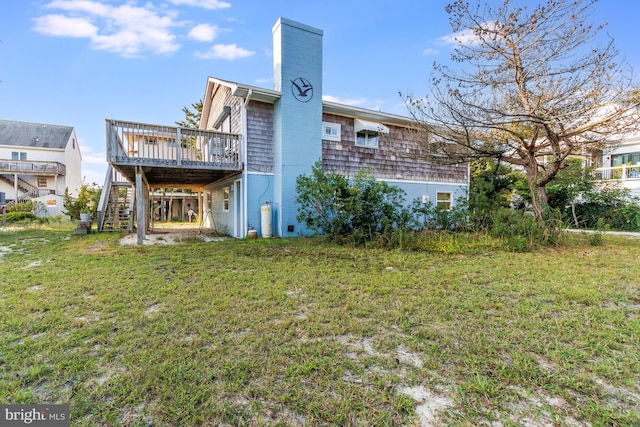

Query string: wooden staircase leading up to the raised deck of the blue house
98 166 133 231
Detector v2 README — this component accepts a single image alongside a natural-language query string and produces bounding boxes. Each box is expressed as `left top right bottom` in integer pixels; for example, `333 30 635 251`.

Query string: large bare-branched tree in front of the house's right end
405 0 640 224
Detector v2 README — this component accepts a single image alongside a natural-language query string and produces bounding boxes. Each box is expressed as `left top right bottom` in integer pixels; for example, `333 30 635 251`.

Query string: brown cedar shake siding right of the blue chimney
322 114 468 184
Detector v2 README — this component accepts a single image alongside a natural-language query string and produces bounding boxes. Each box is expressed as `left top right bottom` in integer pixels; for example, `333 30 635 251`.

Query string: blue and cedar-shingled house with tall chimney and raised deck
99 18 469 243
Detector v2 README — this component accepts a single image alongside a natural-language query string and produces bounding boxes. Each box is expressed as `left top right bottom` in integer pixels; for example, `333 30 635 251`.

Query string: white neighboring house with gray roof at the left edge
0 120 82 216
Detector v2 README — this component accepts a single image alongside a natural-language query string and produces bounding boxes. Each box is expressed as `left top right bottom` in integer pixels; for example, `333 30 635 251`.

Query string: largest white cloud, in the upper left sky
34 0 180 57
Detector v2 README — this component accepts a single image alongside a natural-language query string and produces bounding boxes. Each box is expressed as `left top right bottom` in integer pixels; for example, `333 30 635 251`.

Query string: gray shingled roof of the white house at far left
0 120 73 150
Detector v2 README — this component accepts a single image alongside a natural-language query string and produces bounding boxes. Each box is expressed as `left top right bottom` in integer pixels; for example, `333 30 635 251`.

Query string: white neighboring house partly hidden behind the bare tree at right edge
590 134 640 197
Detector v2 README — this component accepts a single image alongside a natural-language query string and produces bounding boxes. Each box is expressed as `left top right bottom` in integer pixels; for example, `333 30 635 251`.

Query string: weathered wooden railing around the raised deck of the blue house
107 120 241 170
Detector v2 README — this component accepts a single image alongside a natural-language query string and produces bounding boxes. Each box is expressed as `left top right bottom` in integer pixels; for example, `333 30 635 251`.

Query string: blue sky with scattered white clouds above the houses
0 0 640 185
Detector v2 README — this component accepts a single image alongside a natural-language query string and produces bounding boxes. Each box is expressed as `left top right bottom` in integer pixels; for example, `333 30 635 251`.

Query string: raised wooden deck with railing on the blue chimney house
106 120 243 188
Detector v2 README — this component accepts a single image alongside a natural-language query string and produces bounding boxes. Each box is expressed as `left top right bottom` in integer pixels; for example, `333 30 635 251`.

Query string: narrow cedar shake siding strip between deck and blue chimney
247 101 273 173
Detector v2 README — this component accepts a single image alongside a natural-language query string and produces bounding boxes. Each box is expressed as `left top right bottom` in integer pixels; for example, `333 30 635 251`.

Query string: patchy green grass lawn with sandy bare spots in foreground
0 228 640 426
